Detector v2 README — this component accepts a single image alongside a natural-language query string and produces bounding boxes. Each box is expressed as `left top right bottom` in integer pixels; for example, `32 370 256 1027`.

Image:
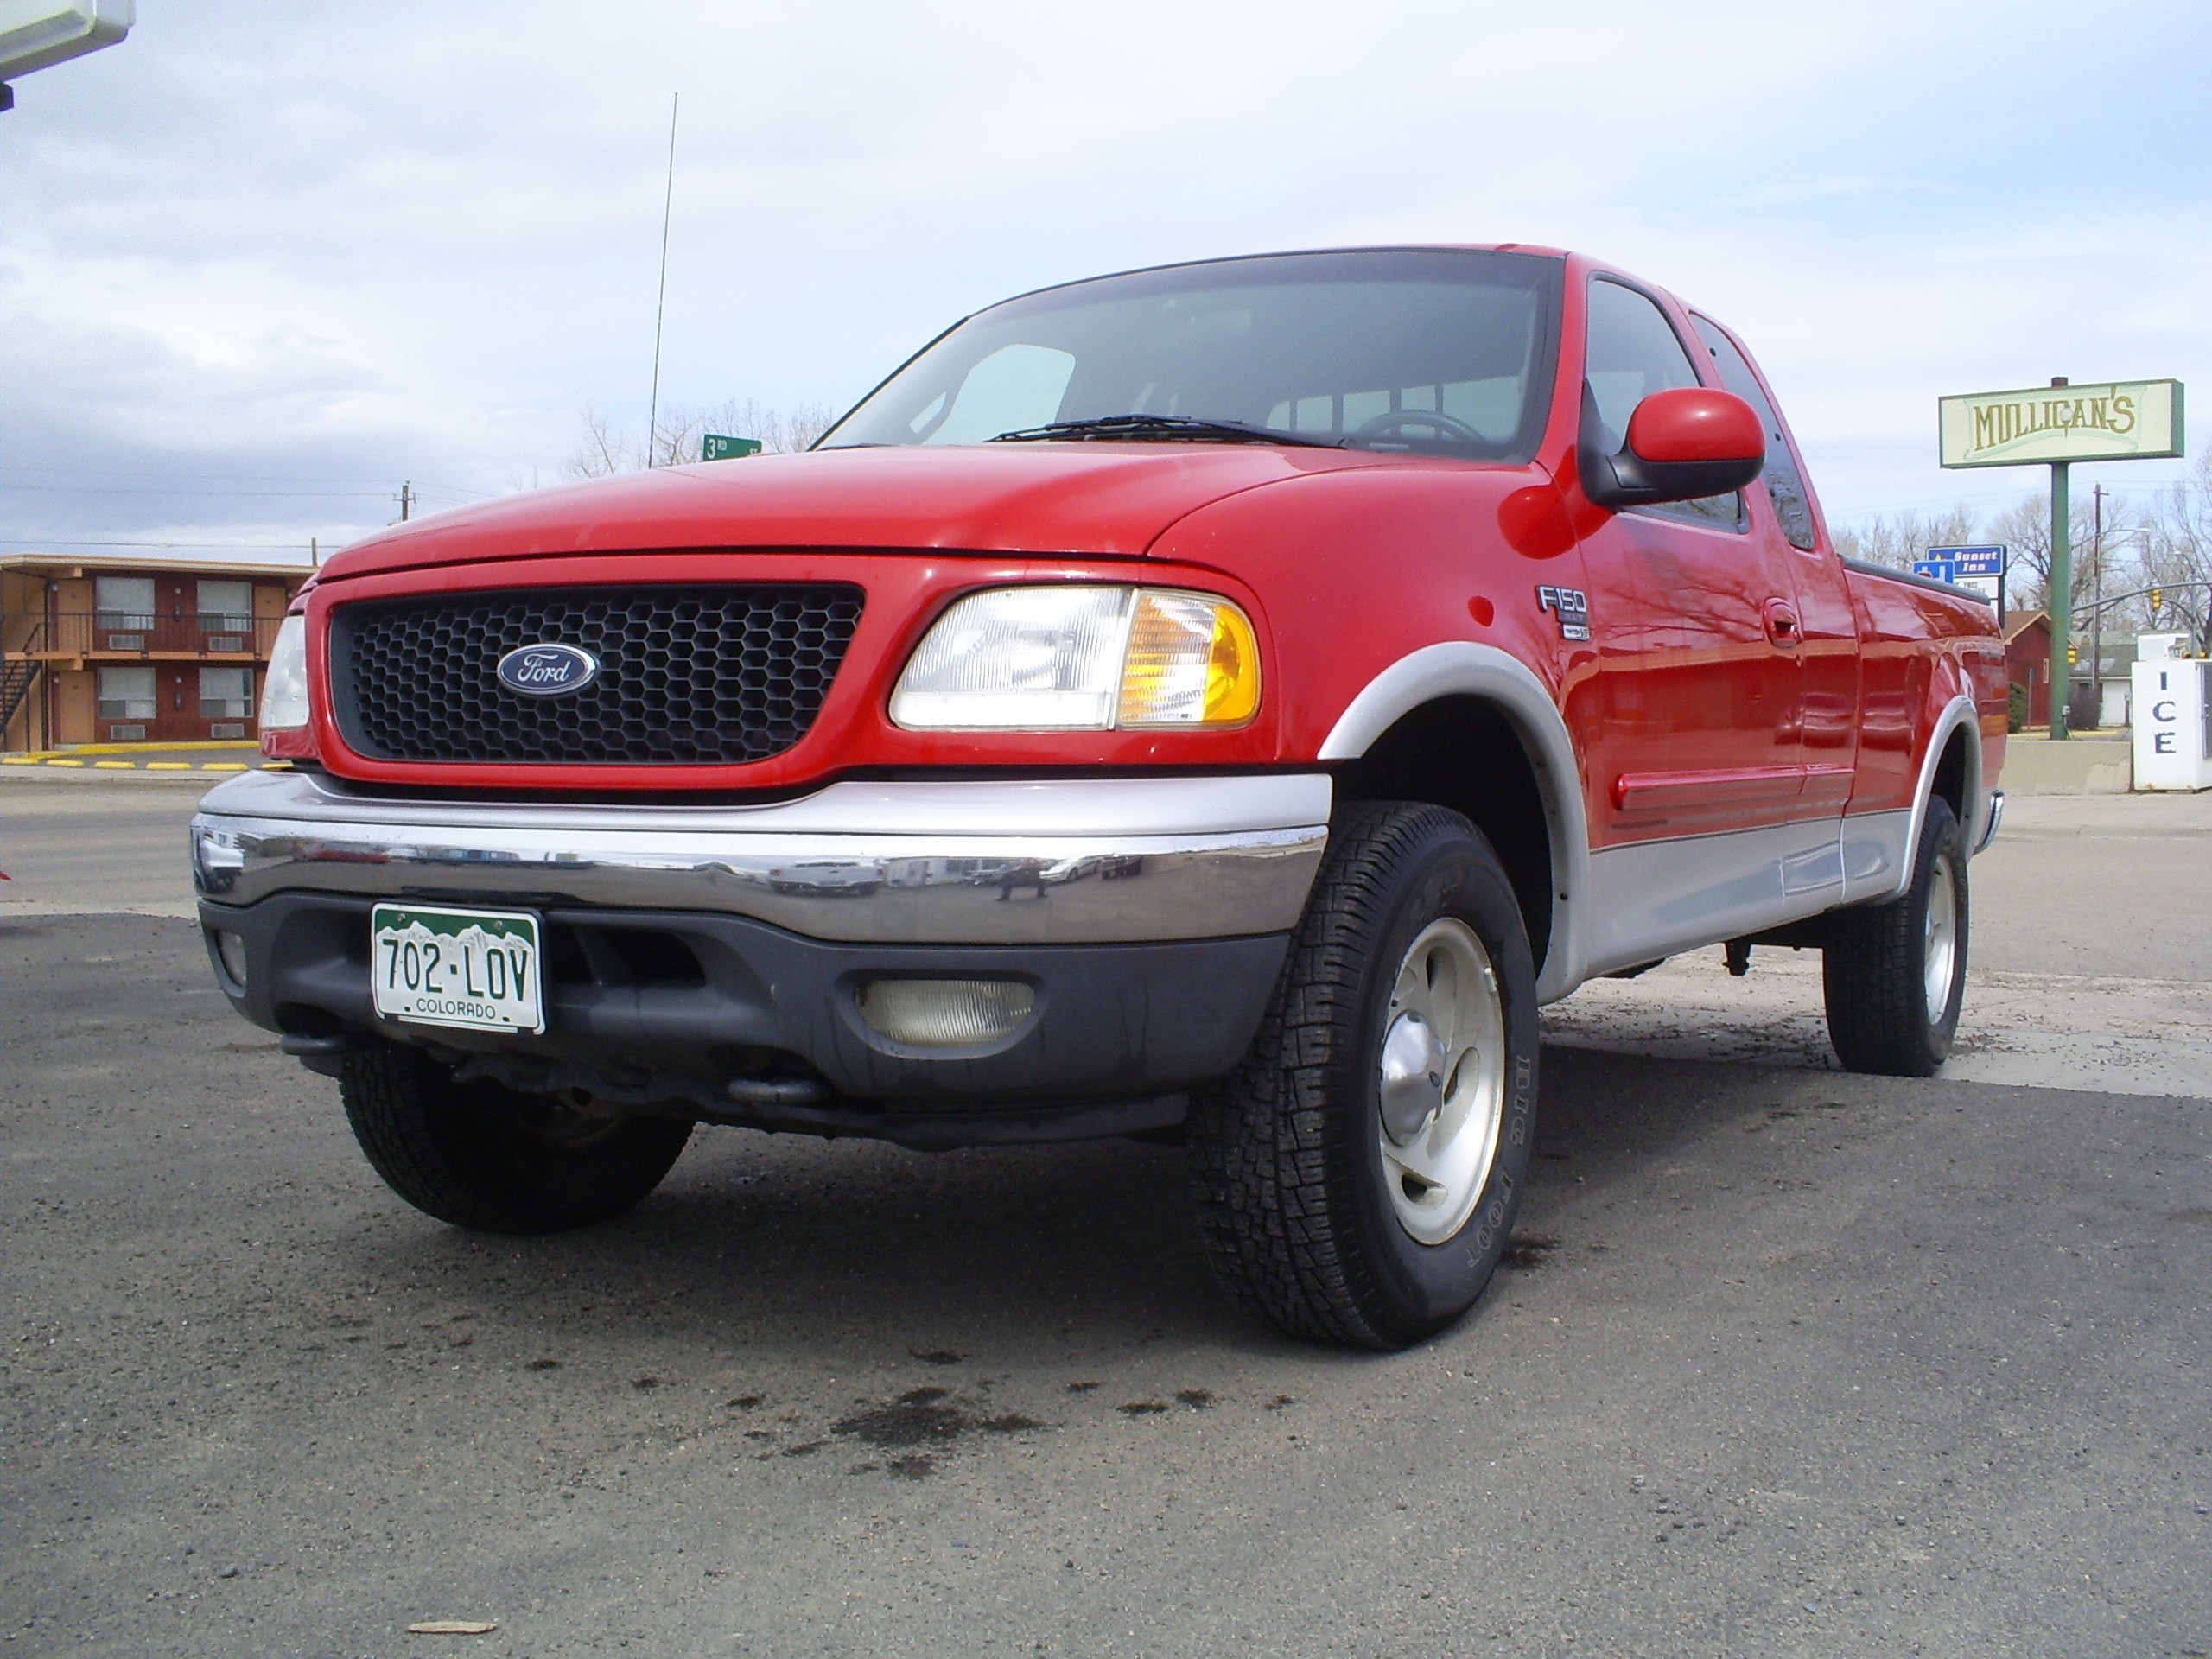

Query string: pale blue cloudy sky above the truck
0 0 2212 557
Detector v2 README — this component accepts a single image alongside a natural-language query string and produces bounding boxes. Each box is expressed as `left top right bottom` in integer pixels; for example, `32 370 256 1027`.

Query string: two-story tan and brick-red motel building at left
0 553 312 754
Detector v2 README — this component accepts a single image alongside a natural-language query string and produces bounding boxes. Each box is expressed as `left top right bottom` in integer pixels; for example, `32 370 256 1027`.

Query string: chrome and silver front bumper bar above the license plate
190 772 1332 944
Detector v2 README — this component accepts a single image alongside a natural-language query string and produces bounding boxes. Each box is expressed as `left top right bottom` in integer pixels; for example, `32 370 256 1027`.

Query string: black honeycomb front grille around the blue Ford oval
329 582 861 766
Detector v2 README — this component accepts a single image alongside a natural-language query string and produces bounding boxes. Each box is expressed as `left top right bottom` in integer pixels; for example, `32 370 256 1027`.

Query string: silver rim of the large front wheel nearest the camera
1376 916 1506 1245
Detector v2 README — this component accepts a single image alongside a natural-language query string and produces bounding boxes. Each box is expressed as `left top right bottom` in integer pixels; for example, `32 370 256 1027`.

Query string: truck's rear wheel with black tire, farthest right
1821 798 1967 1077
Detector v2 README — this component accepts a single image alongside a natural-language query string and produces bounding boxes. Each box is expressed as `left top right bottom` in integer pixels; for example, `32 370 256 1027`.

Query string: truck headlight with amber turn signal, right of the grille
892 586 1259 732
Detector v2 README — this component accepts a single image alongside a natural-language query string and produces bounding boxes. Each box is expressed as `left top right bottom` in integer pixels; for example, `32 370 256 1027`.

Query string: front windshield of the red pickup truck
821 248 1561 460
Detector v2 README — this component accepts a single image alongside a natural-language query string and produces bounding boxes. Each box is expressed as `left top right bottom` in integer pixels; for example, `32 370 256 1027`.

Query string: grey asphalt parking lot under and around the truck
0 777 2212 1655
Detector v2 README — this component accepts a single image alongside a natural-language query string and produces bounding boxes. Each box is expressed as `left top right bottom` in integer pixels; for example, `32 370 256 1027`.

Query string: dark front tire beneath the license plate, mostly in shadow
339 1046 692 1232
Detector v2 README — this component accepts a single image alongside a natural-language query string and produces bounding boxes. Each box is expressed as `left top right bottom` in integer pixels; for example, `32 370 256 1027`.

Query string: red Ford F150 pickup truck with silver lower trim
193 245 2006 1347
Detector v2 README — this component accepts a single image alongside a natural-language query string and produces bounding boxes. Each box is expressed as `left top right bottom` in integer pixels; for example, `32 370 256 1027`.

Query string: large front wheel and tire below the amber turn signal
1190 803 1537 1350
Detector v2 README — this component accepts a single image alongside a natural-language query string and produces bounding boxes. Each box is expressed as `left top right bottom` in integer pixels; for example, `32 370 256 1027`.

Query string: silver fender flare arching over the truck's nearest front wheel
1319 639 1591 1002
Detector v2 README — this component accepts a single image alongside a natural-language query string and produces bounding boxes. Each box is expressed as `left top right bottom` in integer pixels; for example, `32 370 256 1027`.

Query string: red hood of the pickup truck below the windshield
323 442 1391 580
